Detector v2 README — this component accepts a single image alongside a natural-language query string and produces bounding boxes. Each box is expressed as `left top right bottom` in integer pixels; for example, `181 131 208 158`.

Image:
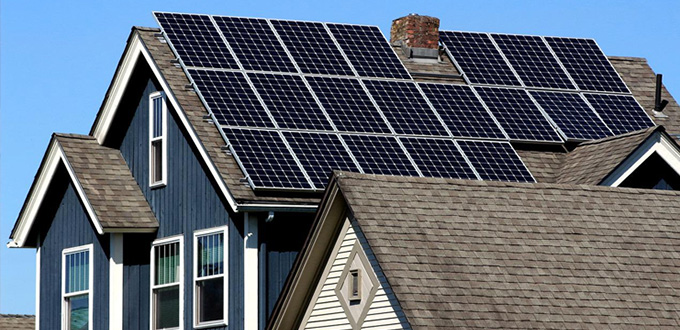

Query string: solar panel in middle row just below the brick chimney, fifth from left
418 83 505 139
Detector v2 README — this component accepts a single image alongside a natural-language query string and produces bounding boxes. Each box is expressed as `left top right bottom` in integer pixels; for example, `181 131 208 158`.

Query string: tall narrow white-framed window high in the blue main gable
149 92 168 187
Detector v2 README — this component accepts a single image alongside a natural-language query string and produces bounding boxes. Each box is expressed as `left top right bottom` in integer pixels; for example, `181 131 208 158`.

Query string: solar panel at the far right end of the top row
545 37 629 93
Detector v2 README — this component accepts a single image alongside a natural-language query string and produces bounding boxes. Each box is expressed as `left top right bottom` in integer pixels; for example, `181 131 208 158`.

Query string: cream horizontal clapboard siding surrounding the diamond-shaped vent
301 220 411 330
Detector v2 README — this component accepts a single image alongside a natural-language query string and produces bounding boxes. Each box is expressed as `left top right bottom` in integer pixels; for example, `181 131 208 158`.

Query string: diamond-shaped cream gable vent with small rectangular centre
335 241 380 329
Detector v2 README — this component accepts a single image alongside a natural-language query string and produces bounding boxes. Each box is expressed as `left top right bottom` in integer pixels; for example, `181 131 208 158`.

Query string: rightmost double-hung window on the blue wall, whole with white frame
194 227 227 327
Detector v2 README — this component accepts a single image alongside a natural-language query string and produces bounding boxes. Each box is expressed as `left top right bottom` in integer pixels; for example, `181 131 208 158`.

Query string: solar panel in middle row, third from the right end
475 87 562 142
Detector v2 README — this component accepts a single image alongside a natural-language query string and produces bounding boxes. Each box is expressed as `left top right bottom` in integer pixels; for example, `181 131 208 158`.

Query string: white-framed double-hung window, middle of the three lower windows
151 237 184 329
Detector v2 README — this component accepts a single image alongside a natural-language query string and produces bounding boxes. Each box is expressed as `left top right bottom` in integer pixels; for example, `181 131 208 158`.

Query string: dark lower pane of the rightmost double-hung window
196 277 224 323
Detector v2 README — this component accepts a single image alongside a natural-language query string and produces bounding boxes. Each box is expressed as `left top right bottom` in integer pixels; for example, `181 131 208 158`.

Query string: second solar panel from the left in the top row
213 16 297 72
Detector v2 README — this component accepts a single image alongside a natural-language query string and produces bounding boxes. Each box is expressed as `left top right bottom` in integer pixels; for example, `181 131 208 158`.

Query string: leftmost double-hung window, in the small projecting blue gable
61 244 93 330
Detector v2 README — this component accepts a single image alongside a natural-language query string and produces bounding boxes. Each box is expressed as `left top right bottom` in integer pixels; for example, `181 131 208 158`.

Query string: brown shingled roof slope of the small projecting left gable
54 134 158 230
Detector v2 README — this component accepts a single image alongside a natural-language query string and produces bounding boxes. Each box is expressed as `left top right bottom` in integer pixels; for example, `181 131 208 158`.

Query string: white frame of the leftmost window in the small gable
61 244 94 330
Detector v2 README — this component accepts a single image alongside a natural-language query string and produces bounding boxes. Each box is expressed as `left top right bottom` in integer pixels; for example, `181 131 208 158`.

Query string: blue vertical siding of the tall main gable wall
120 77 244 330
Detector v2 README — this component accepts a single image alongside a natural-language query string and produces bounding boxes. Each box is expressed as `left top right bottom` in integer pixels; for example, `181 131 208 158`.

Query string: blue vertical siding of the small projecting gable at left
38 177 109 329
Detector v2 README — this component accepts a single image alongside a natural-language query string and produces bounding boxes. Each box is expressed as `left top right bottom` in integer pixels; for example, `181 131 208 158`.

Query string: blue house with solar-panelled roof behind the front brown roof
8 13 680 330
